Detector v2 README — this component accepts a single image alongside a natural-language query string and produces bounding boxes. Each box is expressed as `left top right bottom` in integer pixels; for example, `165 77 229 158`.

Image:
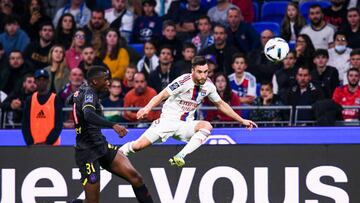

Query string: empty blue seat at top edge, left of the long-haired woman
261 1 289 24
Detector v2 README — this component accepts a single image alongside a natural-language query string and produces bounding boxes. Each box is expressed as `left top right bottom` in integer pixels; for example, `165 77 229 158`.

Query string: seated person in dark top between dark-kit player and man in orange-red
101 78 124 122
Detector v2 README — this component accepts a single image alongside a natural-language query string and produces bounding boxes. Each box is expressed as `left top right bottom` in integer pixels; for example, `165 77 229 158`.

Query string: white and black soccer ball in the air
264 37 289 63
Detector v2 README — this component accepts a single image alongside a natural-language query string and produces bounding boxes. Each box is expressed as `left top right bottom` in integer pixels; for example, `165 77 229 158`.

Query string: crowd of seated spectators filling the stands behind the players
0 0 360 127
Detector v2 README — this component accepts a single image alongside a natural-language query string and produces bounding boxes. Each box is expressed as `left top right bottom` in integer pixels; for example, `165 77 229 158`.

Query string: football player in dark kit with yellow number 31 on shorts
69 66 153 203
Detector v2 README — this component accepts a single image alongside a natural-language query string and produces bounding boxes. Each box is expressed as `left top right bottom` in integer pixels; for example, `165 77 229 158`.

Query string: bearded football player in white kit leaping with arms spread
120 56 257 167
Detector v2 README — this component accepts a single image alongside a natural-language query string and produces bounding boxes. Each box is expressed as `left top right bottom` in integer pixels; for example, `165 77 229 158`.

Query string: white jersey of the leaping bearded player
161 73 221 121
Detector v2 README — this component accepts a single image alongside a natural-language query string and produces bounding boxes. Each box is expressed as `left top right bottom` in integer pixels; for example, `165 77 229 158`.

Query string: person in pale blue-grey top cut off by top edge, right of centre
207 0 236 26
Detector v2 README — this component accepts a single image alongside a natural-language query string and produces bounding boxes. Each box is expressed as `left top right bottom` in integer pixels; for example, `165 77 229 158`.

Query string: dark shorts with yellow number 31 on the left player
76 144 119 186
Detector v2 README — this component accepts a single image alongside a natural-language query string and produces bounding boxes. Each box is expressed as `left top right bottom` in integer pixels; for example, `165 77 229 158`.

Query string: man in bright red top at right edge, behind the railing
332 68 360 121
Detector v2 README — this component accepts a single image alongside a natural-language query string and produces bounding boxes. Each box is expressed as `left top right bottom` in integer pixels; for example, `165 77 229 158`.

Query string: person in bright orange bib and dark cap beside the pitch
21 69 63 146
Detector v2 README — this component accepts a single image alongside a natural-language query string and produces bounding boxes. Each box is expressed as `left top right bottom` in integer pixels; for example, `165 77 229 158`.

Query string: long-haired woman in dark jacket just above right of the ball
280 2 306 42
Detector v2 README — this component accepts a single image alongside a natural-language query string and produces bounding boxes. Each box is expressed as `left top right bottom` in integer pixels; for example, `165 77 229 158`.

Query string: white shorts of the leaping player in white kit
141 118 199 143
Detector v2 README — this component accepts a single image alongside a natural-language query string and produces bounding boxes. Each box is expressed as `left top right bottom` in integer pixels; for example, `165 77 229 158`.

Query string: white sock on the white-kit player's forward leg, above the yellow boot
176 129 210 158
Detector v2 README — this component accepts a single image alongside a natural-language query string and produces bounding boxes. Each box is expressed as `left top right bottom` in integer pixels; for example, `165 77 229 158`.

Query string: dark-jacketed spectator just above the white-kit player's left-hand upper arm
148 45 177 93
